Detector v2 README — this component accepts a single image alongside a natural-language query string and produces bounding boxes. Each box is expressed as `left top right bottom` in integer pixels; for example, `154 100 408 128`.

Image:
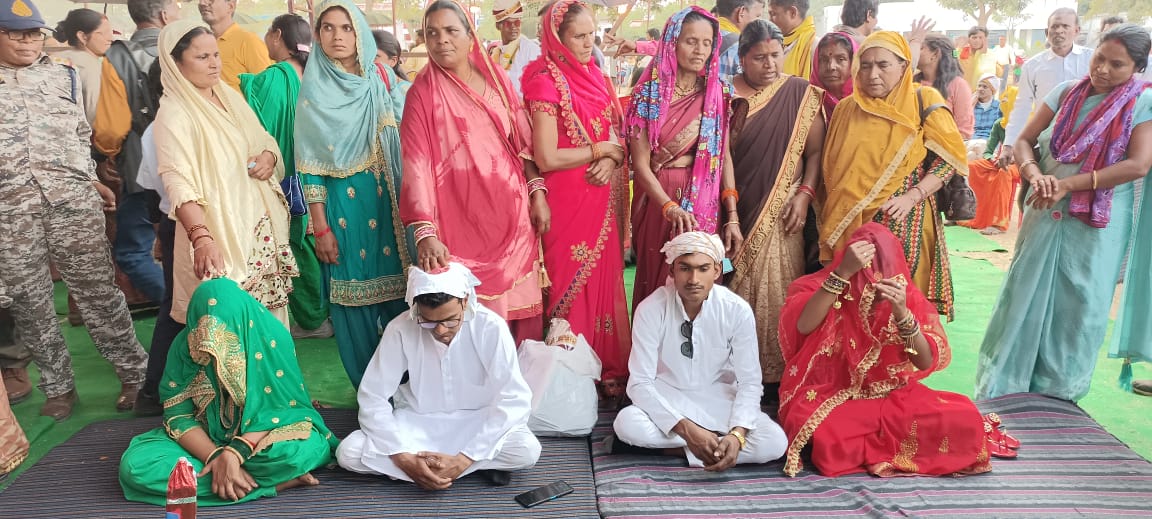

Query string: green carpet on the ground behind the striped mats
0 227 1152 488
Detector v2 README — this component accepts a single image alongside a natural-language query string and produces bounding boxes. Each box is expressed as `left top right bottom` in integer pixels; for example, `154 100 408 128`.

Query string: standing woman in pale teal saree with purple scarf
976 25 1152 402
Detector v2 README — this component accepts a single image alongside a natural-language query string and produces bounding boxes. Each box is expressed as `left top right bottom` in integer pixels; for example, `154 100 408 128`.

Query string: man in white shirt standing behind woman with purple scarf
1000 7 1092 168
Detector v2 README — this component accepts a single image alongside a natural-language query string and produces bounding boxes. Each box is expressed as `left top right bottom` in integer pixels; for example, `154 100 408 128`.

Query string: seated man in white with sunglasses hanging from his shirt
613 231 787 471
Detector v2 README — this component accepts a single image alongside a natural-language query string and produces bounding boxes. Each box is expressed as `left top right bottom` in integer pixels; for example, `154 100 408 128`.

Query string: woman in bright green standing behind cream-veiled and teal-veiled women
240 14 328 338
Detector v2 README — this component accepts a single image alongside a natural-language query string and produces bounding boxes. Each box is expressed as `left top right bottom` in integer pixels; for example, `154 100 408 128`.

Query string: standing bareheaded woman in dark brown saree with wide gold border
728 20 825 391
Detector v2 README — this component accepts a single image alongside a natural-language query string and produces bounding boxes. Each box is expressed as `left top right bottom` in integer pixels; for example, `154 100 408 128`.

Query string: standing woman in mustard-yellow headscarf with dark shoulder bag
820 31 968 320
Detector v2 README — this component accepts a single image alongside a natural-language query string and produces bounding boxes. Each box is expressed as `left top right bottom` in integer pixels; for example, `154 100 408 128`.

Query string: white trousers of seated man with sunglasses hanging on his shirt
612 405 788 467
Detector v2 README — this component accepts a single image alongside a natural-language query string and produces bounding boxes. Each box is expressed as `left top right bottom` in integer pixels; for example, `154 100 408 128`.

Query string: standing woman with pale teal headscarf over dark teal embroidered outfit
296 0 410 387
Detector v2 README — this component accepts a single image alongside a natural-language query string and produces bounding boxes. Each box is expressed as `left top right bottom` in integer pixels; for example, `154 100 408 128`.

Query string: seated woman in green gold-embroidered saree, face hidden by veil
120 277 338 506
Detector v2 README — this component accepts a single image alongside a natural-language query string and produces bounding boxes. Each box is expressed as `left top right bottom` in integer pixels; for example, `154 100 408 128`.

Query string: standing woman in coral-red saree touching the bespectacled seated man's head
400 0 548 343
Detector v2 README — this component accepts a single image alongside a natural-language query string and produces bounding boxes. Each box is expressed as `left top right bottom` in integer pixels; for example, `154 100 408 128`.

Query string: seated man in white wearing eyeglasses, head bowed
336 262 540 490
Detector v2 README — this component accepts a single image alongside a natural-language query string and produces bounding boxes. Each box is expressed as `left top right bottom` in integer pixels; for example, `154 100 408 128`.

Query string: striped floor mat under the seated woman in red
592 395 1152 519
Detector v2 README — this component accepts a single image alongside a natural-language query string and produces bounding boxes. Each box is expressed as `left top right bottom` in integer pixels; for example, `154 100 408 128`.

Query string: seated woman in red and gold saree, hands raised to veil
780 222 1018 476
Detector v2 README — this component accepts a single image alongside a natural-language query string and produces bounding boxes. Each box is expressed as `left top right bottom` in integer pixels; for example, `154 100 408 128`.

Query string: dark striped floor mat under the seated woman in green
0 410 598 519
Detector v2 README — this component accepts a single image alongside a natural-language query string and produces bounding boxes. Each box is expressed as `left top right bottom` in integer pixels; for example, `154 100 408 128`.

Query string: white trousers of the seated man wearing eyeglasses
336 426 540 481
